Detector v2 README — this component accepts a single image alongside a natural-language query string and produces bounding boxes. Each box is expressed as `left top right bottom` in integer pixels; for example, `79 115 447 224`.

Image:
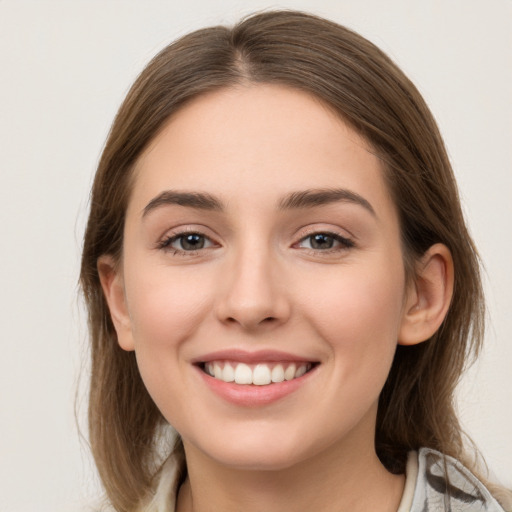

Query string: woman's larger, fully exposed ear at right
398 244 454 345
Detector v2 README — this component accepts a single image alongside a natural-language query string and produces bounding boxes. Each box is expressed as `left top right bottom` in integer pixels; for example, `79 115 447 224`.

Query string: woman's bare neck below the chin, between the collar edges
177 422 405 512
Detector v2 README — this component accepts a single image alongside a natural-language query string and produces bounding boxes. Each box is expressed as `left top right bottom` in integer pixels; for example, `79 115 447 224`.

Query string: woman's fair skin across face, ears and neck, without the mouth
99 85 453 512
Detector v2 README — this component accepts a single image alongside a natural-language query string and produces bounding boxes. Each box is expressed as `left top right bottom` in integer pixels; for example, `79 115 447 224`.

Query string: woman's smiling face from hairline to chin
110 85 412 469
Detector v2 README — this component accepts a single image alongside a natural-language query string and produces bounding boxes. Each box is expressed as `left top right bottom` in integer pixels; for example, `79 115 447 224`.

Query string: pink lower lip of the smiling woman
197 367 316 407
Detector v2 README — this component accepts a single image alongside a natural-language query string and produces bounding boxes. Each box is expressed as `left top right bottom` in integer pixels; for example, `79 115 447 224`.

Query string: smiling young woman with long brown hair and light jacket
81 12 508 512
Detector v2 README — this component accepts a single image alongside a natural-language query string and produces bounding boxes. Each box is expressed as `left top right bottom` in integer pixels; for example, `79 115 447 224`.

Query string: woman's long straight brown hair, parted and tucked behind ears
81 11 492 512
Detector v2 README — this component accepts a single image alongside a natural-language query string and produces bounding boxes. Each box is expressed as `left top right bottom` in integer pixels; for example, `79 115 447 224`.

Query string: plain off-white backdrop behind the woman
0 0 512 512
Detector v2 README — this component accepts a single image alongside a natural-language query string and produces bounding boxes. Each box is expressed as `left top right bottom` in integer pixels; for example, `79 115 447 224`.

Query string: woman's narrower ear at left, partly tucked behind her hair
97 255 134 351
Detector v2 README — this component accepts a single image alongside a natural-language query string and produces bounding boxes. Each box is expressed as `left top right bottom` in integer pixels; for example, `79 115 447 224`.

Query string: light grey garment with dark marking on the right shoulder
411 448 504 512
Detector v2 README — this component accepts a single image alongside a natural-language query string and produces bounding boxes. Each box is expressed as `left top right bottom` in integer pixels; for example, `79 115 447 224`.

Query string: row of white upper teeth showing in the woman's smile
204 361 311 386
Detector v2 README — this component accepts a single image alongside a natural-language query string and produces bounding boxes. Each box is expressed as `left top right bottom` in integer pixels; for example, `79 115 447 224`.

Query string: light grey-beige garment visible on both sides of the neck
141 448 505 512
